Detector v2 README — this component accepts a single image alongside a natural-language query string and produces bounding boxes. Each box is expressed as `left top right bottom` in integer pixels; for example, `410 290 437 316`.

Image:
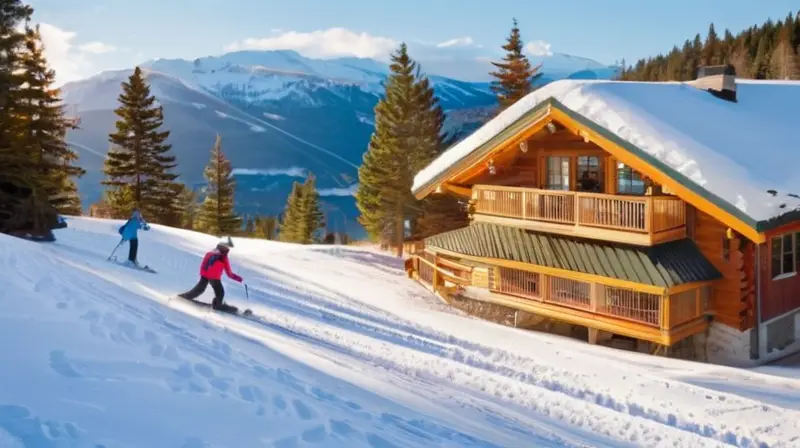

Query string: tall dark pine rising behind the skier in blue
103 67 180 223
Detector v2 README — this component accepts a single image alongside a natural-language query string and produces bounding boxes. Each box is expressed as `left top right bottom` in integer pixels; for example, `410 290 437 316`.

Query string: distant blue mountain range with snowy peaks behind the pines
62 50 614 236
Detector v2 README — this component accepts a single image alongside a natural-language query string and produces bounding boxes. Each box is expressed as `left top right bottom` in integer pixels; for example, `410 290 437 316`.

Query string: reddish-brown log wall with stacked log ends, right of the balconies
686 204 755 330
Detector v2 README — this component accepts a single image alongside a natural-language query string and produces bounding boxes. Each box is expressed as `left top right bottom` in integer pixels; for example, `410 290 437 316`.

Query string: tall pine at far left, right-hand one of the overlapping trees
18 26 85 215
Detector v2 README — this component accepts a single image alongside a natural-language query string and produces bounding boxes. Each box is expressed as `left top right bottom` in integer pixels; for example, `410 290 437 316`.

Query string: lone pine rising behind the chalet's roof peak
489 19 542 112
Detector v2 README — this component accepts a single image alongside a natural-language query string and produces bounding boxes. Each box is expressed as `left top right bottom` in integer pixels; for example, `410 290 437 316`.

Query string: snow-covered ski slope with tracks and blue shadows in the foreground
0 218 800 447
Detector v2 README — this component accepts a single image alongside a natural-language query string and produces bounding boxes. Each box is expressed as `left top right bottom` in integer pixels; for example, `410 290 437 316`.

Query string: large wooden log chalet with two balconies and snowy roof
406 67 800 364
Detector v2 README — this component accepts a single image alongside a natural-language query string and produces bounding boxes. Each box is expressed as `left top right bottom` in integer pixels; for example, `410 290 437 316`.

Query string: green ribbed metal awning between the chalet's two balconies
425 222 722 288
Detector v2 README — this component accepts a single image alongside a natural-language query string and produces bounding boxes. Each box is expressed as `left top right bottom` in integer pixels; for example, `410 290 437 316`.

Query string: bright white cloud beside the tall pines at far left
39 23 114 86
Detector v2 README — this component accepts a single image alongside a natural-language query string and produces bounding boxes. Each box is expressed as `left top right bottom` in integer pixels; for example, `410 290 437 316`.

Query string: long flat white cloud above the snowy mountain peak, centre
225 28 398 60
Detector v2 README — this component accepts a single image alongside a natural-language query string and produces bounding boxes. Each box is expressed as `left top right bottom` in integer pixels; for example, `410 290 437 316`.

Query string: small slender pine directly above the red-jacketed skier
199 135 242 235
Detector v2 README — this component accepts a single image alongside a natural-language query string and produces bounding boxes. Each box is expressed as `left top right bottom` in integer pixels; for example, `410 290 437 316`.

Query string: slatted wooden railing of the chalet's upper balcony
473 185 686 235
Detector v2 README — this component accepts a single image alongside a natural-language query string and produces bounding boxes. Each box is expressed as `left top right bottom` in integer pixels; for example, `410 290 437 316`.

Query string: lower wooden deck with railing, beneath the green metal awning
406 251 711 346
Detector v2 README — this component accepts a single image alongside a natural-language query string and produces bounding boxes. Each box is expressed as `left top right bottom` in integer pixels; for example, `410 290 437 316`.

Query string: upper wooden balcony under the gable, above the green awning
472 185 686 246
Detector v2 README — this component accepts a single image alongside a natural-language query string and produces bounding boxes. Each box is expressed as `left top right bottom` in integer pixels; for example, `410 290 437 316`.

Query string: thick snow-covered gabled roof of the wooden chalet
412 79 800 224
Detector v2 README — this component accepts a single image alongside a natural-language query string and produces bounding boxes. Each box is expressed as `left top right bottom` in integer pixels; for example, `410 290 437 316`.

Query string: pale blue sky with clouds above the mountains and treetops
29 0 800 82
